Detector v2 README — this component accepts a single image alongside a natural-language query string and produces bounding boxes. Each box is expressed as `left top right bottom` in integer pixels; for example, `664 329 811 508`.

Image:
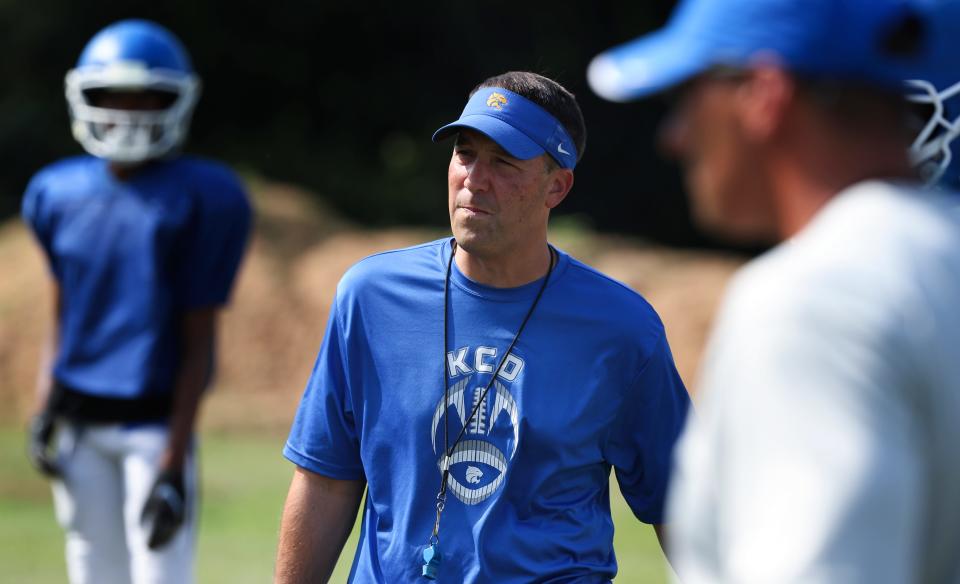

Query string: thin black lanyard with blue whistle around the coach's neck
423 239 557 580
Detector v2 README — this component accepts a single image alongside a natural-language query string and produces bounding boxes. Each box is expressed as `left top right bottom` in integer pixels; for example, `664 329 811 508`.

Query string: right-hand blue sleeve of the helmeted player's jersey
179 174 251 309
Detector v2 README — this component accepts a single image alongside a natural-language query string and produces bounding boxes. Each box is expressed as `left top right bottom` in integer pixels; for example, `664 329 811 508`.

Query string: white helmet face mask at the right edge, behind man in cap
907 79 960 188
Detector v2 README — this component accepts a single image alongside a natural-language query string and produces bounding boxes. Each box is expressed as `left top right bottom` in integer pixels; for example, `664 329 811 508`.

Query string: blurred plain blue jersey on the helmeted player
22 156 250 398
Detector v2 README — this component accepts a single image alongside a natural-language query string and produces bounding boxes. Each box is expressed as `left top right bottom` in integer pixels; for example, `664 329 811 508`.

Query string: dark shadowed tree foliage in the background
0 0 720 244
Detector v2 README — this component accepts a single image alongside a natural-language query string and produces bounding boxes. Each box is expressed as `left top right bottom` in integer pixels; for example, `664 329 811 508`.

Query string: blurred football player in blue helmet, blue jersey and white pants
23 20 250 584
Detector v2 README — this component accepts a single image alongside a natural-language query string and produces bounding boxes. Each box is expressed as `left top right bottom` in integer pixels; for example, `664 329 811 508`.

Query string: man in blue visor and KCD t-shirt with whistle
276 72 689 584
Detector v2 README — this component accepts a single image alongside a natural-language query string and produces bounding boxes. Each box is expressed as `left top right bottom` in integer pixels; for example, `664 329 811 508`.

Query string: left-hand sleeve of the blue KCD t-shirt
283 303 364 480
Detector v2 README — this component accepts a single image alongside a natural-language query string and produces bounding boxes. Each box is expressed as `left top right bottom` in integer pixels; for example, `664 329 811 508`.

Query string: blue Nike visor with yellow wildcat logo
433 87 577 170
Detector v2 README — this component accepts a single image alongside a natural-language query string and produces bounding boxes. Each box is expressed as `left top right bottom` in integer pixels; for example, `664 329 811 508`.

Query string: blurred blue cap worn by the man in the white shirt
587 0 960 101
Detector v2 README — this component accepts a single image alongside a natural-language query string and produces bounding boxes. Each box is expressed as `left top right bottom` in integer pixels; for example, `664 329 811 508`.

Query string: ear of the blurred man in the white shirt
737 64 796 142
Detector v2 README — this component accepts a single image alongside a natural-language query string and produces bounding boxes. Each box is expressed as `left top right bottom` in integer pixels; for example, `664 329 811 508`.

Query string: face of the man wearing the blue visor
447 130 572 257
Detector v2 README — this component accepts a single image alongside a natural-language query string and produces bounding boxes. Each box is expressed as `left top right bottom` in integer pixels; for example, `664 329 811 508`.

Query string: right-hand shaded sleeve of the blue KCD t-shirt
604 334 690 524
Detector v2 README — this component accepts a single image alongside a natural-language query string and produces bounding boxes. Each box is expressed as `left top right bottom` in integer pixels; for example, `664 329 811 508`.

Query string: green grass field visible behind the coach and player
0 426 667 584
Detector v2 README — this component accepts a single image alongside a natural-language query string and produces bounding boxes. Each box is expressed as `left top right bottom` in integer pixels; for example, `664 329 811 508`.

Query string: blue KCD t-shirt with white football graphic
284 239 689 584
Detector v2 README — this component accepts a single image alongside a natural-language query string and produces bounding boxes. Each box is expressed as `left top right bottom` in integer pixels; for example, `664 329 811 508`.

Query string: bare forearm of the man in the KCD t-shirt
274 467 366 584
